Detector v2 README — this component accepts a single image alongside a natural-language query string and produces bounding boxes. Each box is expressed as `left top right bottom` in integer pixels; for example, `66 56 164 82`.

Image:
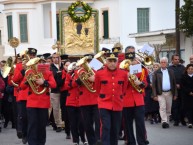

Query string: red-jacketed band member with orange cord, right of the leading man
123 47 147 145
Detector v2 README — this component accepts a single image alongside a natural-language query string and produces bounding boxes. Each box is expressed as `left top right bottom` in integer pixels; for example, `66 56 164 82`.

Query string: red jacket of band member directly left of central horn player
65 72 79 107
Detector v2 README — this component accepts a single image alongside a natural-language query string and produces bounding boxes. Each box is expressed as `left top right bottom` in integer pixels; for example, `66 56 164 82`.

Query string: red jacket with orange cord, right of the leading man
123 69 147 107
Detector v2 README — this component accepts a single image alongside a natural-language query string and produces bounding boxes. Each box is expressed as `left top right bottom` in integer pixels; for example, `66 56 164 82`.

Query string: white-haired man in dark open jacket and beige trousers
152 57 177 128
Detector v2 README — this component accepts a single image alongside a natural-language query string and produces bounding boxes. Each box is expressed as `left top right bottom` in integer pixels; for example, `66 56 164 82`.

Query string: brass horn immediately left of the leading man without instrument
76 56 96 92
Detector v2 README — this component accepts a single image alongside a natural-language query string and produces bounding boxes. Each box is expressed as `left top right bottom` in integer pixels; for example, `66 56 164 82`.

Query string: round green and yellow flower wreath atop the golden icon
68 1 92 23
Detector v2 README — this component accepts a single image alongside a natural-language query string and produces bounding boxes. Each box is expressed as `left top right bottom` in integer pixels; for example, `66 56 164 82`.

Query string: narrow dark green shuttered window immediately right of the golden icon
102 10 109 39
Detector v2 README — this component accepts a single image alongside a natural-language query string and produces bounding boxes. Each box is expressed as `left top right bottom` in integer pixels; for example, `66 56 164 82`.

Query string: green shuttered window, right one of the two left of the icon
19 14 28 43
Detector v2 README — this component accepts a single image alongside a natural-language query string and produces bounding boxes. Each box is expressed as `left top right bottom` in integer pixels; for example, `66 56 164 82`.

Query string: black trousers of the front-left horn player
27 108 48 145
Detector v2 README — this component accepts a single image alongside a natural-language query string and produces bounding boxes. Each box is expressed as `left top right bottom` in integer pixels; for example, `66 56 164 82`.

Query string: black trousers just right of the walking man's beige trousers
60 90 70 135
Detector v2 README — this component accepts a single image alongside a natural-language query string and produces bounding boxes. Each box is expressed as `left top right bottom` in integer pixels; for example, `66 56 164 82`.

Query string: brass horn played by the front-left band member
25 57 47 95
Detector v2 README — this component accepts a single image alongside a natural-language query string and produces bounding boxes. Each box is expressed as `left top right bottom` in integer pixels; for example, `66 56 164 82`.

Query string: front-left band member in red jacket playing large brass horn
21 58 56 145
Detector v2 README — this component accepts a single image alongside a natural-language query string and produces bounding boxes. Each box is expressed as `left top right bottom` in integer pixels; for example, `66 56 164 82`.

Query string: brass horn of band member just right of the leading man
119 59 142 93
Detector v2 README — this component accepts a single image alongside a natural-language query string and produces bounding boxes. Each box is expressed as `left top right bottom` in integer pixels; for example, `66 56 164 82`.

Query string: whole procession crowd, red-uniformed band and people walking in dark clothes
0 43 193 145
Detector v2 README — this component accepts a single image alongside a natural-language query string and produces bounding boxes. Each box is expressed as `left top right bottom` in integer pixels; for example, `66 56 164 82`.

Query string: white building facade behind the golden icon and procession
0 0 193 63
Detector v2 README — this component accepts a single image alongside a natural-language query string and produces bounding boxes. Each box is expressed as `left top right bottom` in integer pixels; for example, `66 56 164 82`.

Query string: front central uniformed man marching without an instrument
95 53 128 145
